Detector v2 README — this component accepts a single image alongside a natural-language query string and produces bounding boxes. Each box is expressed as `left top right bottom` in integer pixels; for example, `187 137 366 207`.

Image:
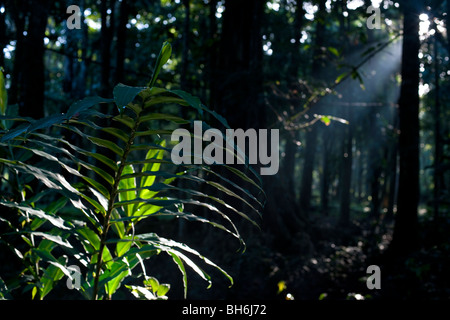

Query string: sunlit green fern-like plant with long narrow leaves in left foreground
0 43 262 299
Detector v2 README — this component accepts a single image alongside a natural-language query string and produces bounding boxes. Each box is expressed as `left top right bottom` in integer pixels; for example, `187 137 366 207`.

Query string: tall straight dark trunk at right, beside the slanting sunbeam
391 1 421 254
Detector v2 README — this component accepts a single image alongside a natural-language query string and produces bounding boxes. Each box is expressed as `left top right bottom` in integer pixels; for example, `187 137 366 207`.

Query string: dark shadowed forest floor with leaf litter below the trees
125 208 450 300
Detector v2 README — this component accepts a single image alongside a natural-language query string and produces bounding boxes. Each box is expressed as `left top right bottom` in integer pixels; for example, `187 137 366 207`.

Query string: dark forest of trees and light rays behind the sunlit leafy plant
0 0 450 300
